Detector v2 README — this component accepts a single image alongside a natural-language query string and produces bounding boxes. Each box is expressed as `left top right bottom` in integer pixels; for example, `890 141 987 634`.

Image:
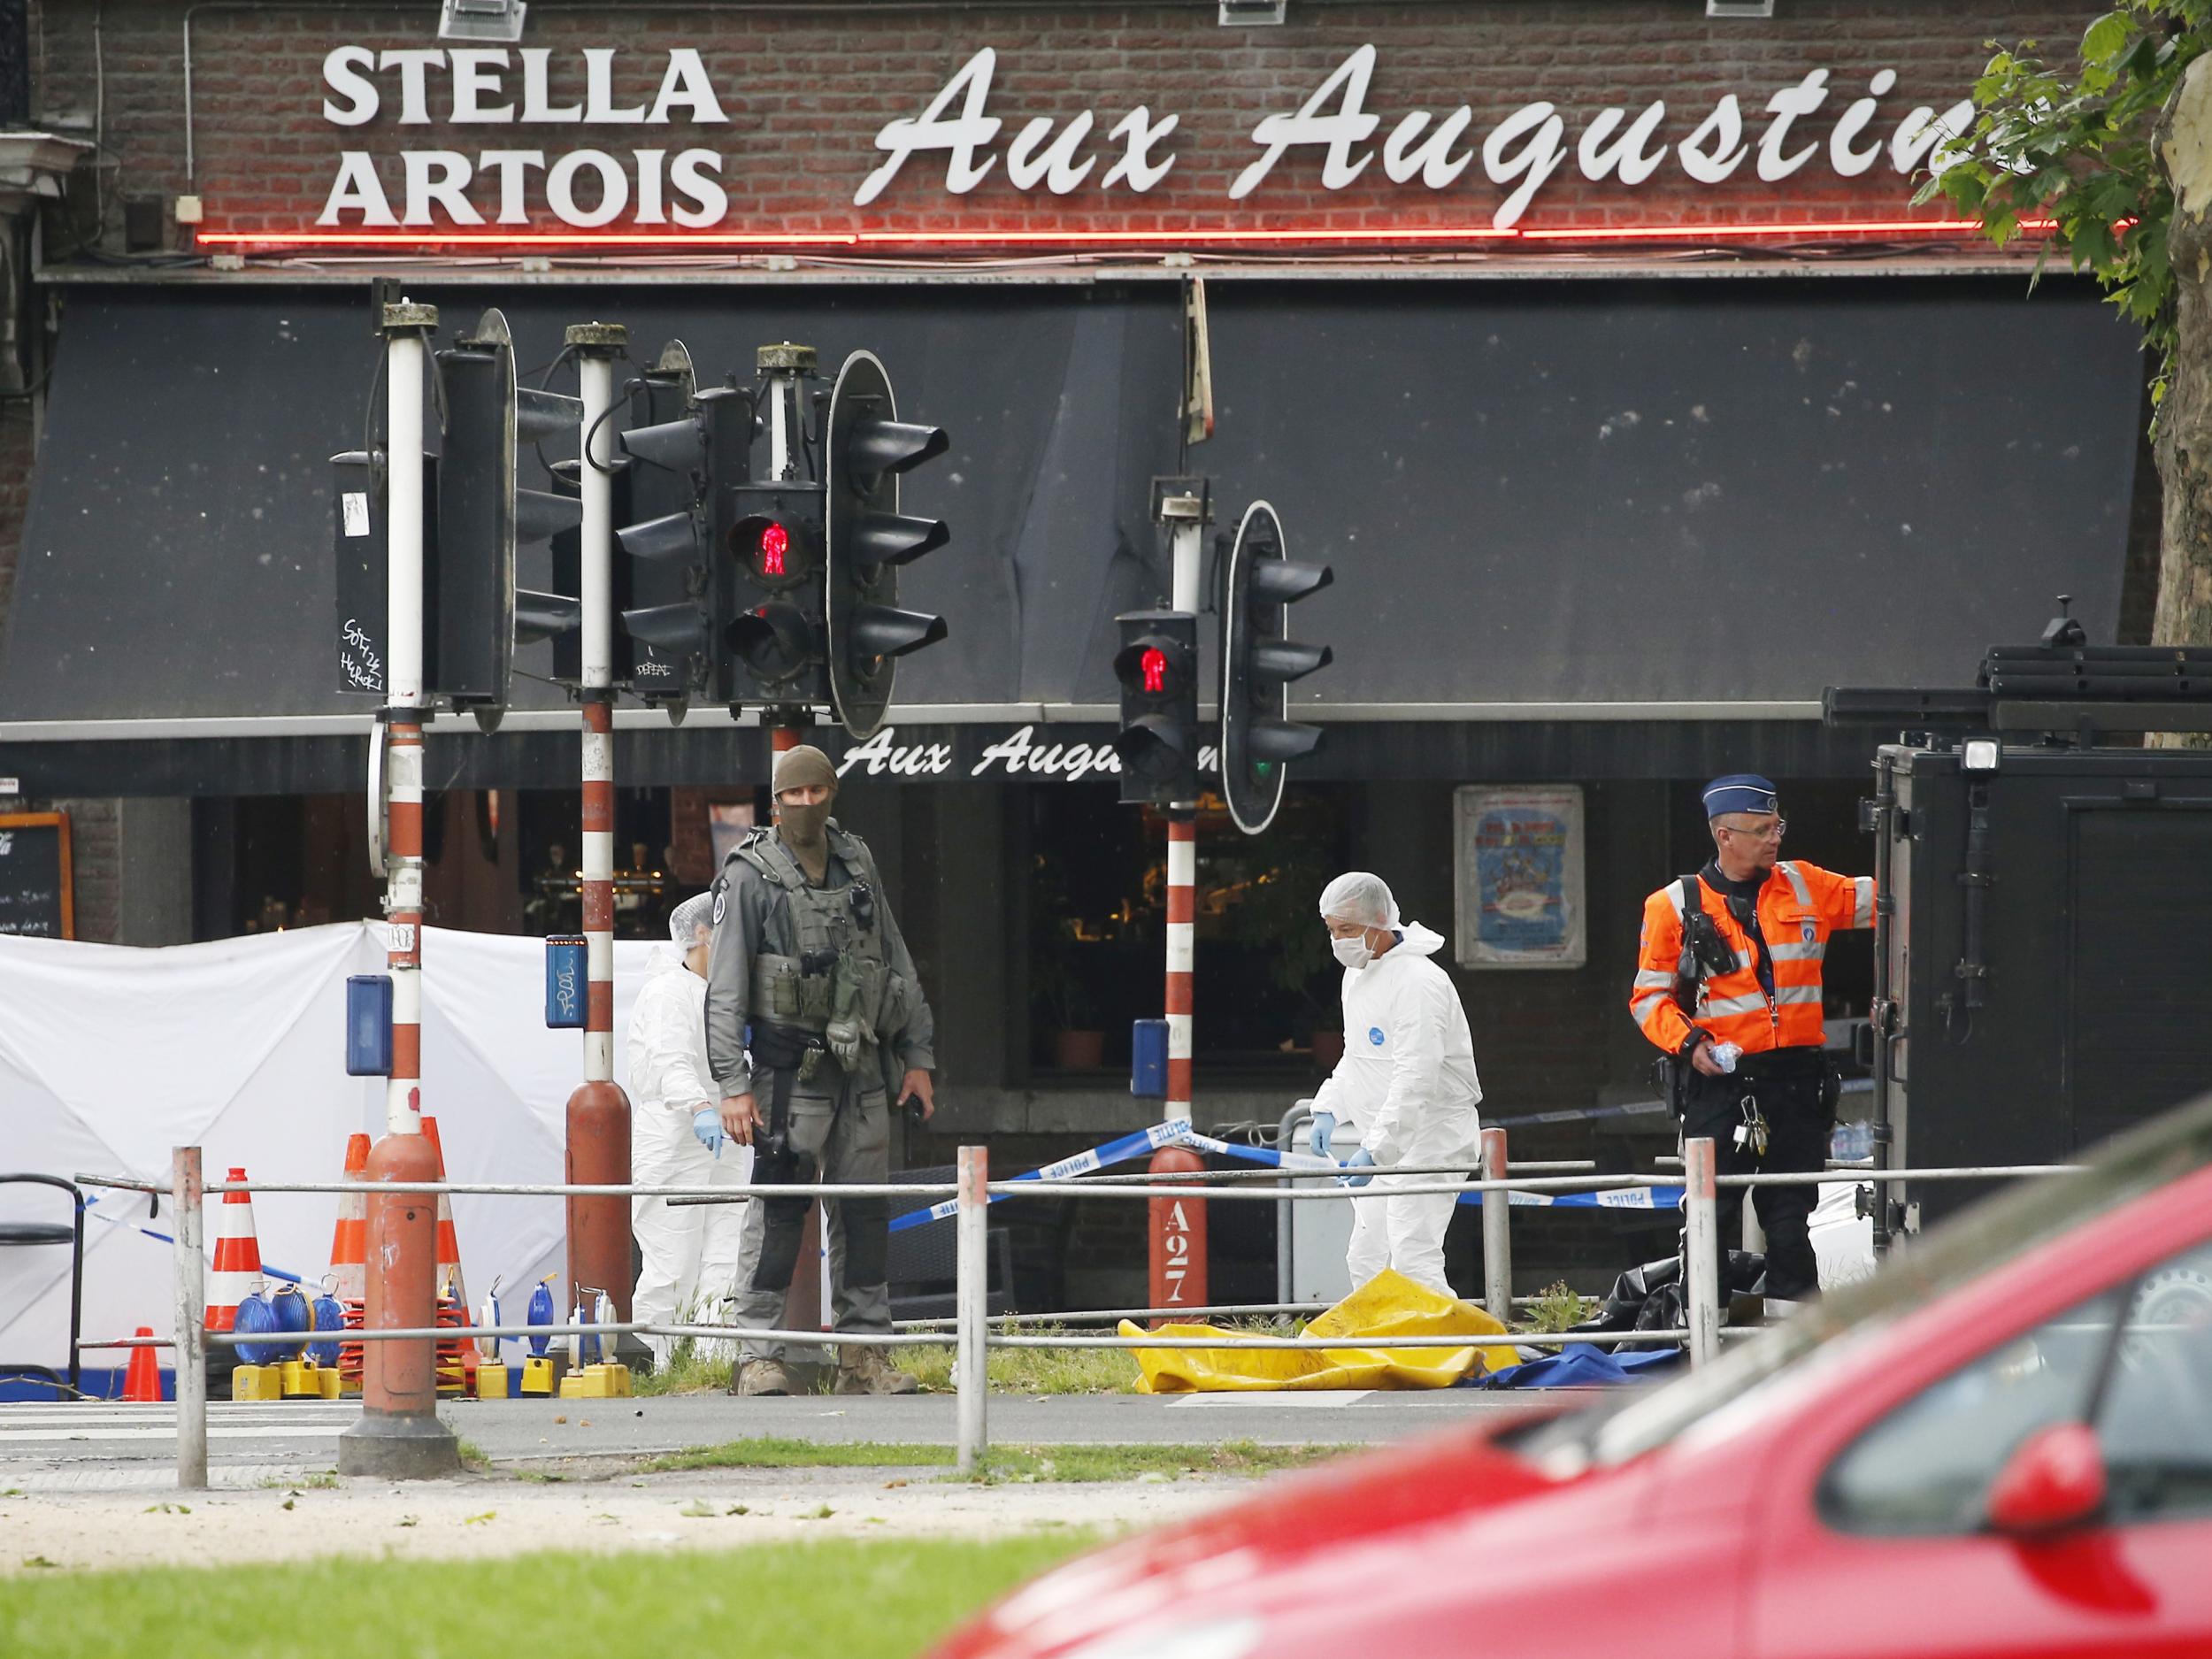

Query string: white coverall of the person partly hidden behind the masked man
628 947 752 1367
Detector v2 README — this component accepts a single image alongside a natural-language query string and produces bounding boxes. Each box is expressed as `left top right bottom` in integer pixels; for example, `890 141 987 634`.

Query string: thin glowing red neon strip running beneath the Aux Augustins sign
195 219 2057 250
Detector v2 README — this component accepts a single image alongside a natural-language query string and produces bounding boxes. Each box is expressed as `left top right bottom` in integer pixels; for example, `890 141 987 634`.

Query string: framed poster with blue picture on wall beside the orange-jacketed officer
1451 783 1588 969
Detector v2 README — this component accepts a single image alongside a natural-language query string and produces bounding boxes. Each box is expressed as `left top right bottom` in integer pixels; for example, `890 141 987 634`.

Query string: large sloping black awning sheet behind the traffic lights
0 279 2141 741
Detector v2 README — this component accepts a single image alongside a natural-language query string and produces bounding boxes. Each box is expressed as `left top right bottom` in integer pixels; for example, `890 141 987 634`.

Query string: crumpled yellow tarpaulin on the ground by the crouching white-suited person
1122 1268 1520 1394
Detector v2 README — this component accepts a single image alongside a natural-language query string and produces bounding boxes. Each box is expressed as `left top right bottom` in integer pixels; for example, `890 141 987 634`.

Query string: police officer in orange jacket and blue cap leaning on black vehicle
1628 772 1874 1301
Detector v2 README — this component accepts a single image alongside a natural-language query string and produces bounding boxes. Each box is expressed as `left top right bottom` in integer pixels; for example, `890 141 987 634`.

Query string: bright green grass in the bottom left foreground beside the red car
0 1522 1095 1659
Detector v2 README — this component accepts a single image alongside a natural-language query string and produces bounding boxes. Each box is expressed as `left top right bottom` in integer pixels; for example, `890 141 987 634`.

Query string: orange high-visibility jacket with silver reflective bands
1628 861 1874 1056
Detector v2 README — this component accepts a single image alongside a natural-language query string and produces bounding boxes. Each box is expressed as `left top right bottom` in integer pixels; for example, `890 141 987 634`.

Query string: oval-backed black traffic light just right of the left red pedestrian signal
821 352 951 739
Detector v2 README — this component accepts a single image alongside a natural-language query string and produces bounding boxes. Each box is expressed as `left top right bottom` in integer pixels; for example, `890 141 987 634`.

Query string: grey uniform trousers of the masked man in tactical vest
737 1079 892 1361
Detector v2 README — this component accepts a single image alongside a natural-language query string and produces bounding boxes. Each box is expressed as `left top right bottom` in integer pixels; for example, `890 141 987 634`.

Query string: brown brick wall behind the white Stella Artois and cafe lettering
34 0 2104 253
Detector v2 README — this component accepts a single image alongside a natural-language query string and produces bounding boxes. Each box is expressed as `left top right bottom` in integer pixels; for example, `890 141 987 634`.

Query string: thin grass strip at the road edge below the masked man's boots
637 1436 1354 1482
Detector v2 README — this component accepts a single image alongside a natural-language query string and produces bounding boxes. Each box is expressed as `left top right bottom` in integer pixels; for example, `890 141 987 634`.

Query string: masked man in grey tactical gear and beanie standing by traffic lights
706 746 936 1394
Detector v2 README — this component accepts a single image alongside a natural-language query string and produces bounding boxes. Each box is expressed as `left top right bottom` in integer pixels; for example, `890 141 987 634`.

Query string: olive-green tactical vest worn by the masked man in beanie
733 823 914 1066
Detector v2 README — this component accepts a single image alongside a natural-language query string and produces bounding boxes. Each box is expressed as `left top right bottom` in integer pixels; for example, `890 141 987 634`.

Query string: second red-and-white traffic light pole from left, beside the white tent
566 323 631 1321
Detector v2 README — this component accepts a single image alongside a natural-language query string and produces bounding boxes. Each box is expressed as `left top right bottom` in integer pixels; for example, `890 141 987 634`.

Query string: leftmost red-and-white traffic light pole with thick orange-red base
339 299 460 1480
